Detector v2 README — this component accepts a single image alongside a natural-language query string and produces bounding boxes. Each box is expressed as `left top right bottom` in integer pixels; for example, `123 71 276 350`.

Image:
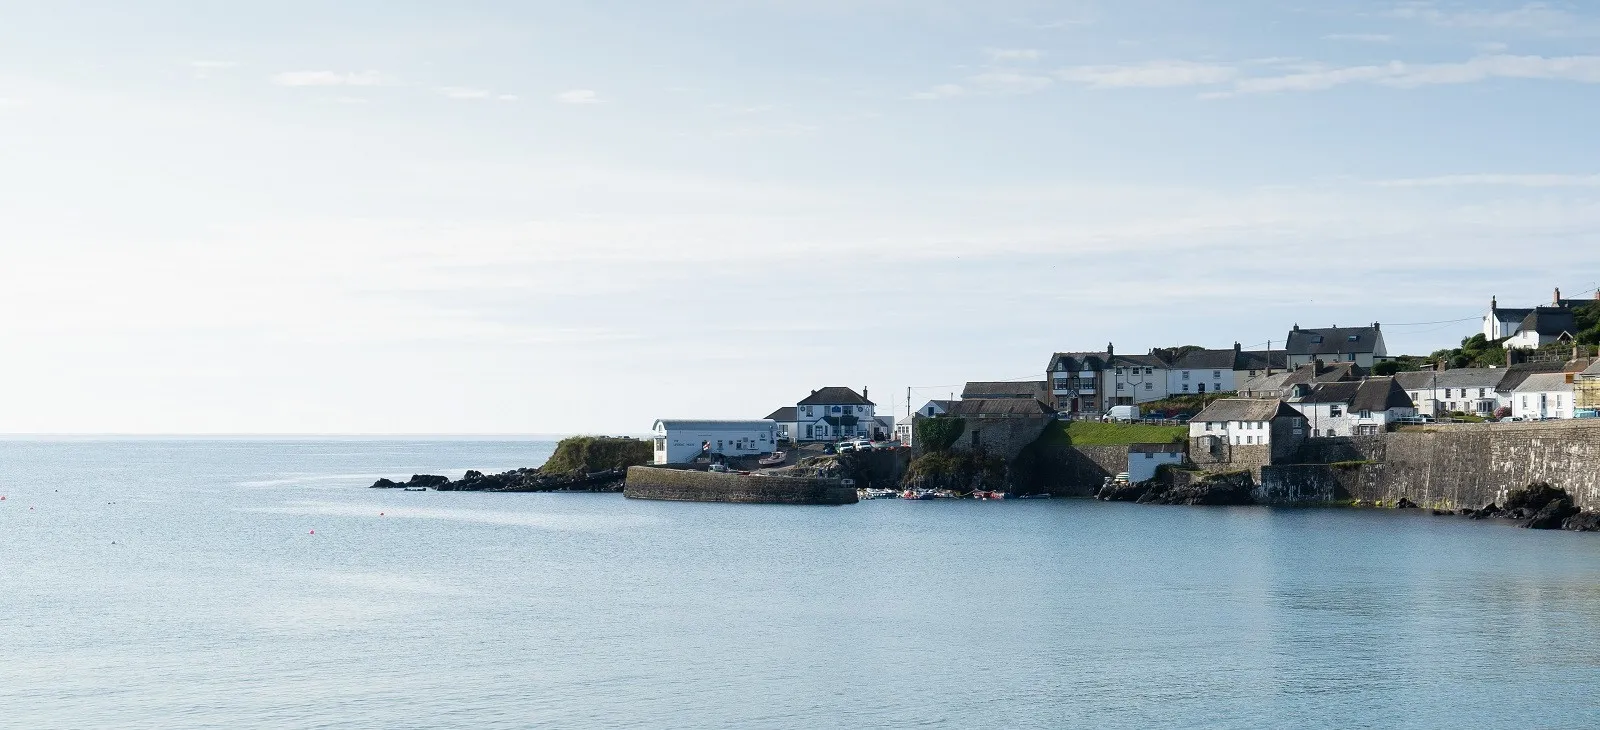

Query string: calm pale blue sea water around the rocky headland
0 440 1600 730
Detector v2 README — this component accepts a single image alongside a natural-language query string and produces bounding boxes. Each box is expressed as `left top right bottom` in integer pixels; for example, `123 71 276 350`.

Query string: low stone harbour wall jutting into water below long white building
622 466 856 504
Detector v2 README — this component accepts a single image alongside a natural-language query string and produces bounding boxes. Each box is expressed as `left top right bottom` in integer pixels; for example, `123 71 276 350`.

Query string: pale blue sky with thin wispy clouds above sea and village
0 0 1600 434
